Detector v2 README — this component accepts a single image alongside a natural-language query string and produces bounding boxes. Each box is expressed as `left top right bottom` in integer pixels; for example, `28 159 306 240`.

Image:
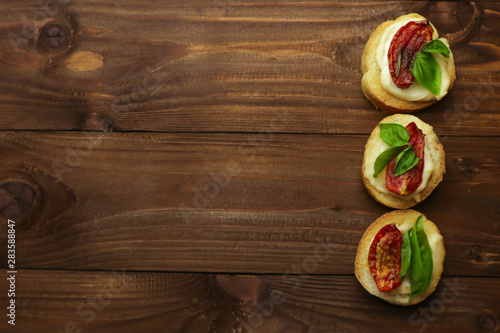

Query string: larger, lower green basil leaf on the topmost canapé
411 52 441 95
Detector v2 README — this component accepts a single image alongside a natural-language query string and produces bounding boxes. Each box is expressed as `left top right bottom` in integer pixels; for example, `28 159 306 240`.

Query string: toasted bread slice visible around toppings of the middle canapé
361 114 446 209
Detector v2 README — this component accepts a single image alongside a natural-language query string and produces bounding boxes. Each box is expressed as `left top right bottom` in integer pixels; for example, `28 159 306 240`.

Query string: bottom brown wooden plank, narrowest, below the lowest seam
0 270 500 333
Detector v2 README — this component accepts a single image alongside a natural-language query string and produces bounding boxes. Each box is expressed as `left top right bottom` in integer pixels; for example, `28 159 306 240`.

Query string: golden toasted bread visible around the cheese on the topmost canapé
361 13 456 113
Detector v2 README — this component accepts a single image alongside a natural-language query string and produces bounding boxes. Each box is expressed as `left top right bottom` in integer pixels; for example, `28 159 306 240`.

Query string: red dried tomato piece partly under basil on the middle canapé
385 122 425 195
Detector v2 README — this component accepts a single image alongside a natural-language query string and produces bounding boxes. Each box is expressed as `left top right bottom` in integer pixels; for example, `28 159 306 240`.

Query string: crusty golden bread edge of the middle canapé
361 114 446 209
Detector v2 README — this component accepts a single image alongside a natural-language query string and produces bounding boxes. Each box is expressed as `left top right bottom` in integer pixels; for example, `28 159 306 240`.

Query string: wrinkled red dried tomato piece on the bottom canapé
368 223 403 292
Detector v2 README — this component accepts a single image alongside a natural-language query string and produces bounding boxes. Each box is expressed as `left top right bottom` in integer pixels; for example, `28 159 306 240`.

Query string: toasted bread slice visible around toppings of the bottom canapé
354 209 446 306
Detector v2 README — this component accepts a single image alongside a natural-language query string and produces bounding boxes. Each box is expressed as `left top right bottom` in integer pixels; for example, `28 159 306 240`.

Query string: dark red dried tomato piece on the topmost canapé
388 21 433 88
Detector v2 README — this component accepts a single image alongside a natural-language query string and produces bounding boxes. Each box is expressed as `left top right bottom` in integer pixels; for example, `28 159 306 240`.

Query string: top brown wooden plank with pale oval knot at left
0 0 500 136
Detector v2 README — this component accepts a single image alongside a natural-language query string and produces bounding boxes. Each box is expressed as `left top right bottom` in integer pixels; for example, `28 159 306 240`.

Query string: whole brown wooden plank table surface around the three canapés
0 0 500 333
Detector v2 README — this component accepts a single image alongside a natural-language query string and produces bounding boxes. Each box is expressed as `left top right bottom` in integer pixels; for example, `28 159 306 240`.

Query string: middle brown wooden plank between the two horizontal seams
0 131 500 276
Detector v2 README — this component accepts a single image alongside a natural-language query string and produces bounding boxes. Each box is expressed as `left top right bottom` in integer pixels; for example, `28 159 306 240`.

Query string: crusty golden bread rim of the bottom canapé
354 209 446 306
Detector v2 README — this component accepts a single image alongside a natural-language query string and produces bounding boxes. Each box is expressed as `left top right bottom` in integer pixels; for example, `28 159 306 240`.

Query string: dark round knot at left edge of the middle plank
0 181 36 218
